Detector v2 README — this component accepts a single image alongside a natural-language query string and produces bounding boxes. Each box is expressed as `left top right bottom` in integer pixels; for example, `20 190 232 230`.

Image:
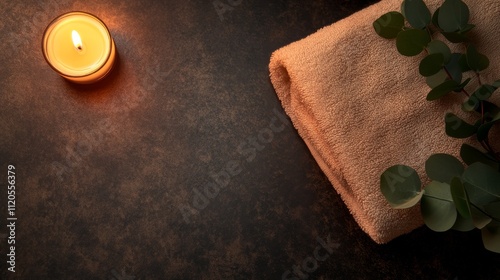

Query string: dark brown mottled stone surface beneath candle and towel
0 0 500 280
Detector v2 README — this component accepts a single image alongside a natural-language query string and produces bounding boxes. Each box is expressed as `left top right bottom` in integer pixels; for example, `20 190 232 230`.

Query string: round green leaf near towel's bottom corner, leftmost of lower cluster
380 165 423 209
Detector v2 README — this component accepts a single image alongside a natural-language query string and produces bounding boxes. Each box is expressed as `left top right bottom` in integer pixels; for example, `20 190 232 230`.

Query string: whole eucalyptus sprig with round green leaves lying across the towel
373 0 500 253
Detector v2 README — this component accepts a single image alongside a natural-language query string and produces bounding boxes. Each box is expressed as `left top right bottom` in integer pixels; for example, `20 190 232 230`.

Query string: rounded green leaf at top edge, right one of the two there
438 0 469 32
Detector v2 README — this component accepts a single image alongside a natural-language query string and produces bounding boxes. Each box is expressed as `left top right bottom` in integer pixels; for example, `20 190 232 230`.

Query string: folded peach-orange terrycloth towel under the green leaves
269 0 500 243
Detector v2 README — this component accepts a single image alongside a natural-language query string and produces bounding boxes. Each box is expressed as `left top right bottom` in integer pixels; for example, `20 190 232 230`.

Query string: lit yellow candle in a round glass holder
42 12 116 84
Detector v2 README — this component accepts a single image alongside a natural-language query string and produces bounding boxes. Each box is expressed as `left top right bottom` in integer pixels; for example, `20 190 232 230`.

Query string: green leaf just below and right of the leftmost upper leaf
396 29 431 56
